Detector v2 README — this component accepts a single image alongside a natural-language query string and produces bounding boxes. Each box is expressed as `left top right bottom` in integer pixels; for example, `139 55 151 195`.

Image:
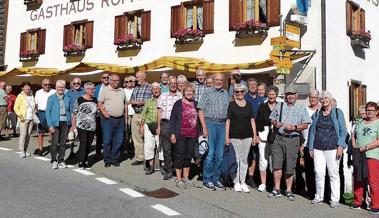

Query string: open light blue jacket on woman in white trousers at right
307 108 347 150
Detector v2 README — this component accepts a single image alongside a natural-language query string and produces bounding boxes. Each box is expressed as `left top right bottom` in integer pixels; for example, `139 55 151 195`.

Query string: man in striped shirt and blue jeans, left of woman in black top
198 73 229 190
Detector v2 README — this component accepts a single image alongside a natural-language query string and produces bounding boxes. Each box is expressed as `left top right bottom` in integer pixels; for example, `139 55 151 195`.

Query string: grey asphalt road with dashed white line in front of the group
0 135 374 218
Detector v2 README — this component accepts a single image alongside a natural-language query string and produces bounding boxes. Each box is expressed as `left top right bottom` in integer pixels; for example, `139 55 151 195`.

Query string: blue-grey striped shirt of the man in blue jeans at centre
197 87 229 120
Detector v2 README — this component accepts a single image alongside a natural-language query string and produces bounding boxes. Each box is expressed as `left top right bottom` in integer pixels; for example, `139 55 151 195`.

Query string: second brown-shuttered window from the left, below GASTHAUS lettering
63 21 93 49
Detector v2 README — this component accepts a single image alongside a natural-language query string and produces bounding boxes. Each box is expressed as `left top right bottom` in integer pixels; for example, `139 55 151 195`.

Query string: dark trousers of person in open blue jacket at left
50 121 68 163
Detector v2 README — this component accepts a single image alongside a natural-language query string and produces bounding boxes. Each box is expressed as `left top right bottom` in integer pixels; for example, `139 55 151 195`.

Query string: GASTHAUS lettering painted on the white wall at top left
30 0 130 21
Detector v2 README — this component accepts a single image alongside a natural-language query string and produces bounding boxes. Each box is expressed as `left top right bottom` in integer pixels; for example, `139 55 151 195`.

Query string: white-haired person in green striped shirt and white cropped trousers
139 82 163 175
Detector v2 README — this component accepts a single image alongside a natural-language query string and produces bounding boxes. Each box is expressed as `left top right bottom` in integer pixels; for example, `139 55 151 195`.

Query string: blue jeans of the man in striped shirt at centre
203 121 225 184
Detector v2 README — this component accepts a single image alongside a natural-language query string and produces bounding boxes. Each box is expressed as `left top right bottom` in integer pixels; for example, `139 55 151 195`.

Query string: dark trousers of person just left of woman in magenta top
159 120 173 172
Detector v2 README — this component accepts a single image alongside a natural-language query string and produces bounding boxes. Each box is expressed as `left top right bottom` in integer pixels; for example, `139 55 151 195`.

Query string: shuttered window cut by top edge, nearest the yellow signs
229 0 280 30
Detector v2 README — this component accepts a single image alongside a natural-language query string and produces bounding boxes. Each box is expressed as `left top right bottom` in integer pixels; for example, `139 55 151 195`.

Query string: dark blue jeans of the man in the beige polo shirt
101 117 125 164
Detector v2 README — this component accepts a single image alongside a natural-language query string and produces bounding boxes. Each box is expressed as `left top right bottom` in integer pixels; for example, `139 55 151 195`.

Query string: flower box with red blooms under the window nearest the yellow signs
233 20 269 38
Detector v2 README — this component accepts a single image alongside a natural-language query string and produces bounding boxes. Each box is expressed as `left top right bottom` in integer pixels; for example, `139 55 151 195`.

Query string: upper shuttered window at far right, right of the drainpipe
346 1 366 36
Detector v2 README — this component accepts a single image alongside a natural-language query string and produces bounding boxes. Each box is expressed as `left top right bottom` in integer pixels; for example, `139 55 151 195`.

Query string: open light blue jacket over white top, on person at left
46 94 72 128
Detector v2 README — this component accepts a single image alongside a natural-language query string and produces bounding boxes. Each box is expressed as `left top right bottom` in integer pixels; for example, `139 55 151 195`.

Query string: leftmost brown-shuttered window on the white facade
20 29 46 57
